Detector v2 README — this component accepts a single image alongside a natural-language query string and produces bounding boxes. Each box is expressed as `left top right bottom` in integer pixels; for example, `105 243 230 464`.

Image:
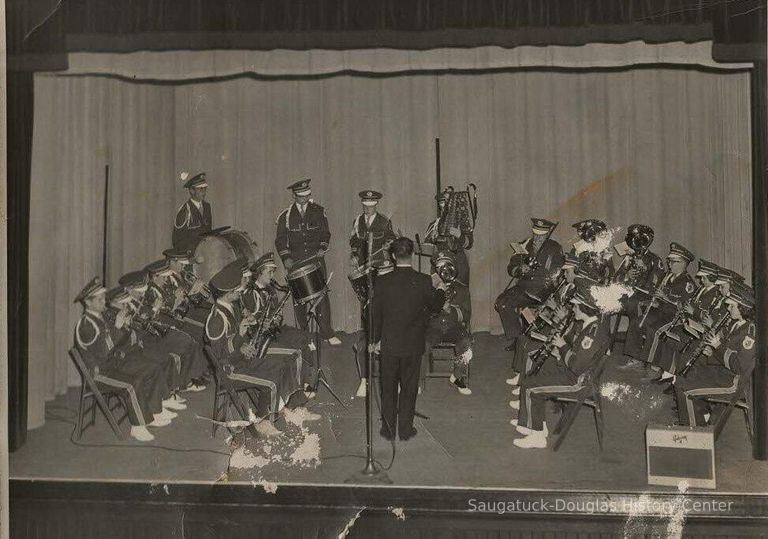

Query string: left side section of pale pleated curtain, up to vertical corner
29 75 174 428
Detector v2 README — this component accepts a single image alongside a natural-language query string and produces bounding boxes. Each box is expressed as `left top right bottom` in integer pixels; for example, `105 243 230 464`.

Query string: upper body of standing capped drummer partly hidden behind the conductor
349 191 395 266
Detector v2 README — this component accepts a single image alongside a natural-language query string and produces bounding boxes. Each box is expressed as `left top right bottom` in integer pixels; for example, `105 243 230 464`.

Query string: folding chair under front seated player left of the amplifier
552 344 610 451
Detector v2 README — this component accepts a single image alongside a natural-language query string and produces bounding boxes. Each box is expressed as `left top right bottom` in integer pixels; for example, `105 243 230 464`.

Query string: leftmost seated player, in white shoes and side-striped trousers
75 277 174 442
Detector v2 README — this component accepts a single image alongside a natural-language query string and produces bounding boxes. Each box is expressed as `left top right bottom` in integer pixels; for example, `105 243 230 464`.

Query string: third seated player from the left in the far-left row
119 264 206 391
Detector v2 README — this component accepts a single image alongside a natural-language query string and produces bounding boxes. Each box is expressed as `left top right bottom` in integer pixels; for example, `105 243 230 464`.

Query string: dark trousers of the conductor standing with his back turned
380 354 421 436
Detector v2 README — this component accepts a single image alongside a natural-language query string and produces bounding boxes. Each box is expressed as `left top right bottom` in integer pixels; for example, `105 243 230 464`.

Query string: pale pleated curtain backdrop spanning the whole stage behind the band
30 62 751 426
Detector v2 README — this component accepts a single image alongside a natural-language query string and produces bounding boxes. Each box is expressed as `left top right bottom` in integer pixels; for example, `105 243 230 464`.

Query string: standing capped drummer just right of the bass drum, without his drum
275 179 341 345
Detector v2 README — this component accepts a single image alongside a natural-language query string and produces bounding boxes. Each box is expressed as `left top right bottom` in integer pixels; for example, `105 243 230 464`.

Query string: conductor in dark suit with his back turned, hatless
369 237 445 440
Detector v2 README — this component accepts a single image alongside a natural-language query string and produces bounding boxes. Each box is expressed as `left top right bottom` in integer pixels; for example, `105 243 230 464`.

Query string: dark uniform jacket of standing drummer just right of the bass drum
275 201 331 263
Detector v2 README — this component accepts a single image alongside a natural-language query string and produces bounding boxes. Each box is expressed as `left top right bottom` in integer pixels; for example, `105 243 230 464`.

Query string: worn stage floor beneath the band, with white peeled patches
10 333 768 493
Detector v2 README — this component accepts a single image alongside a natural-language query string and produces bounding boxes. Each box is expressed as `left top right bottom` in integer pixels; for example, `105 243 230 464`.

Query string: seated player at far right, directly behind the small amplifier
675 283 756 427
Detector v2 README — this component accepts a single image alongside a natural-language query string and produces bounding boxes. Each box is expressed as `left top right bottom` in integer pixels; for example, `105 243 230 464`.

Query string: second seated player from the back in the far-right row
648 259 721 386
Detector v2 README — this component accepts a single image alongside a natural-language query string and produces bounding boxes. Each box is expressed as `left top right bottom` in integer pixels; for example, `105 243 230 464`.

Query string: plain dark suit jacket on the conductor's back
372 267 445 357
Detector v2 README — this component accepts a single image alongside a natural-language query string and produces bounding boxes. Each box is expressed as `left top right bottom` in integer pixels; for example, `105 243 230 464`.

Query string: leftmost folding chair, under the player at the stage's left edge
69 347 128 440
